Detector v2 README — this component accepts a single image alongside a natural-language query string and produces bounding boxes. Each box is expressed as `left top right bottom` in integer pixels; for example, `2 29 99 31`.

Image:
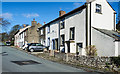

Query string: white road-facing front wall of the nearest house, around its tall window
63 9 86 55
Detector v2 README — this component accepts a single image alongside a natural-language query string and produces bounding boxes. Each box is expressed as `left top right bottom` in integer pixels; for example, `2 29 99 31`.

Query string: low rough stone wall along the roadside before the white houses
55 53 111 68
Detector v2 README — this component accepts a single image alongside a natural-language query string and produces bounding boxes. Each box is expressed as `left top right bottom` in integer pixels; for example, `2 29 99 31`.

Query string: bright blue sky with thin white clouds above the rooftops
2 2 118 31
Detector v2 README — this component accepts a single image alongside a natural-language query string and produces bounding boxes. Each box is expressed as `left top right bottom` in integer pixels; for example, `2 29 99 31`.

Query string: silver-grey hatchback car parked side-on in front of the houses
27 43 47 52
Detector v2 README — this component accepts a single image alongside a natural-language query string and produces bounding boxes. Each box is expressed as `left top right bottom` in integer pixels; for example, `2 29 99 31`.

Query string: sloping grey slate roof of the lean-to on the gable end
92 27 120 41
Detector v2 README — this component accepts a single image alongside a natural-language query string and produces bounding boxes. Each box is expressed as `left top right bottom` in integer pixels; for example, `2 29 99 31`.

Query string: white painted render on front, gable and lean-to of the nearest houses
42 0 120 56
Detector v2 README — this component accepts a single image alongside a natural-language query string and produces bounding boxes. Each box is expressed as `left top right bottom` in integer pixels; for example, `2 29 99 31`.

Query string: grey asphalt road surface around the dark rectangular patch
2 46 85 72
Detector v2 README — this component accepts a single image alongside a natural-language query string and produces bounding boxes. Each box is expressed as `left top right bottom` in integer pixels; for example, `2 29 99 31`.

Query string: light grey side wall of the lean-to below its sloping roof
92 28 116 56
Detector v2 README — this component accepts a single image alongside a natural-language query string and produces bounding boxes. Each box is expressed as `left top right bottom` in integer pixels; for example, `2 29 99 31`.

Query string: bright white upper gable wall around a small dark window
91 0 115 30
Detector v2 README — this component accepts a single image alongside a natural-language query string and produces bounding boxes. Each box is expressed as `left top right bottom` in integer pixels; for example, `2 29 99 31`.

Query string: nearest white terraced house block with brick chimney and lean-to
38 0 120 56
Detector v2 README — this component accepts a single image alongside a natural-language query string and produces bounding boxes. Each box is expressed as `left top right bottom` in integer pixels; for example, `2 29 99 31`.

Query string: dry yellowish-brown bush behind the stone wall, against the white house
85 45 97 56
